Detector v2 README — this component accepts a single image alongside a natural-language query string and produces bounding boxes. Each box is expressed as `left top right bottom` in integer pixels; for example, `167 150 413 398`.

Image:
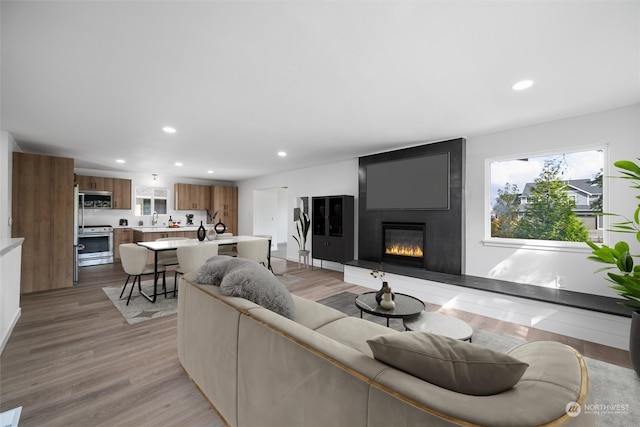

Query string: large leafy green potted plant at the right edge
587 158 640 375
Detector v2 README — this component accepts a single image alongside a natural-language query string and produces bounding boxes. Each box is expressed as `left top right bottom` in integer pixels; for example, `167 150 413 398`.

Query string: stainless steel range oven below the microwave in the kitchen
78 225 113 267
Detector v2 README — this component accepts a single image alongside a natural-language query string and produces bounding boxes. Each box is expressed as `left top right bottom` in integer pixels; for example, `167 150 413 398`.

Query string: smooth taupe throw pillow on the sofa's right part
367 331 529 396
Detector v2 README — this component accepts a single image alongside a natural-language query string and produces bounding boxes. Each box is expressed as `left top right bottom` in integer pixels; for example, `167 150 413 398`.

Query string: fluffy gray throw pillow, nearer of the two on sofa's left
220 260 295 319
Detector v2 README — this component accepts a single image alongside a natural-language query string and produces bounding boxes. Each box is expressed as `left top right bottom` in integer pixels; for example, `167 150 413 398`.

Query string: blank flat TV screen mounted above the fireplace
366 153 449 209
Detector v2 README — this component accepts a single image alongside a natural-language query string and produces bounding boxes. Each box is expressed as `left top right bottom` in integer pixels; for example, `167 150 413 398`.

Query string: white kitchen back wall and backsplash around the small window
75 168 235 227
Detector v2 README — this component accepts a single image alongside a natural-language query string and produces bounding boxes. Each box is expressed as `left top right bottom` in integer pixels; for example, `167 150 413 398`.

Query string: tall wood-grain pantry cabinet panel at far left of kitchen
11 152 76 293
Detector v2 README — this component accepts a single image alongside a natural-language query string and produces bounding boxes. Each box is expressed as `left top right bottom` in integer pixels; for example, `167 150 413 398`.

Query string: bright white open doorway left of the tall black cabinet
253 187 289 259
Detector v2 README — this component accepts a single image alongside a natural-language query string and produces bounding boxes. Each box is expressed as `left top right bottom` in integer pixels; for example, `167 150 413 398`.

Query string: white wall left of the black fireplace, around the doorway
238 159 358 270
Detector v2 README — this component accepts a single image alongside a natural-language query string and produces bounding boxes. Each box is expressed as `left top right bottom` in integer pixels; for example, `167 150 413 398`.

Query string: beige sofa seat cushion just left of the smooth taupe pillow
316 317 396 357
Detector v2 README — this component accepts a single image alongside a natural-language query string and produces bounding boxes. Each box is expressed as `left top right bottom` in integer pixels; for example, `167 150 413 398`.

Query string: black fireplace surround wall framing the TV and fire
358 138 466 274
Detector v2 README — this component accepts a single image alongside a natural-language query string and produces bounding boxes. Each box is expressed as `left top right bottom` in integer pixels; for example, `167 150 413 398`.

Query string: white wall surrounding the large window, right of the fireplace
465 105 640 296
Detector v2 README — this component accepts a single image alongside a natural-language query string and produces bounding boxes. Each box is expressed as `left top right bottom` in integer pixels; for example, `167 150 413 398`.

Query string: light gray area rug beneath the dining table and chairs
102 274 302 325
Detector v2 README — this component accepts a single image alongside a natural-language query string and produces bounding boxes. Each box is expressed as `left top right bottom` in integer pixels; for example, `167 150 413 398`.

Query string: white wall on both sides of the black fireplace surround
238 105 640 296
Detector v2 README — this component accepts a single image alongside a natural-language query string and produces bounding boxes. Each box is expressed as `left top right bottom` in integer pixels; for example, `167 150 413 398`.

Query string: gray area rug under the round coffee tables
318 292 640 427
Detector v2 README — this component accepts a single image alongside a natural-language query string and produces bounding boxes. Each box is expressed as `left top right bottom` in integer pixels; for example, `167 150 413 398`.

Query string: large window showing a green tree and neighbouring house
489 148 605 242
